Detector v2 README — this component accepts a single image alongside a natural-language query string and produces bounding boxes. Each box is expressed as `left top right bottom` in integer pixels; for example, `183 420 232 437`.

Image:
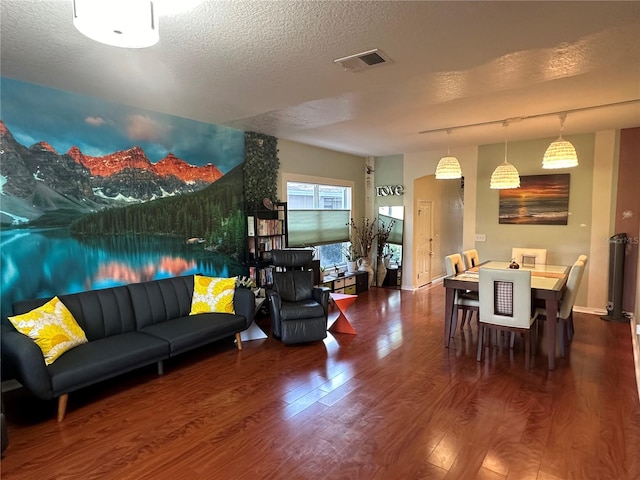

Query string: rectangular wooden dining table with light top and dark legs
443 260 571 370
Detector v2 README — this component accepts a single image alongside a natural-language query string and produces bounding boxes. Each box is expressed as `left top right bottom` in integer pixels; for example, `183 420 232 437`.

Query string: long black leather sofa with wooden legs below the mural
1 275 255 421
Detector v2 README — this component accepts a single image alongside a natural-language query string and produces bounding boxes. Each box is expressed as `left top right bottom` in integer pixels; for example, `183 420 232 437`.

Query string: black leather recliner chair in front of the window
267 250 329 344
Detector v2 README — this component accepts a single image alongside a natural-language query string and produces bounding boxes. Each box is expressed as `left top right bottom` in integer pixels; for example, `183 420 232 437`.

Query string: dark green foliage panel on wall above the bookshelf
243 132 280 210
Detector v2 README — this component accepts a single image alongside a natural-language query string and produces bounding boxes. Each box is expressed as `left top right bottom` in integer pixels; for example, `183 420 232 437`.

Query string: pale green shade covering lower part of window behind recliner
287 210 351 247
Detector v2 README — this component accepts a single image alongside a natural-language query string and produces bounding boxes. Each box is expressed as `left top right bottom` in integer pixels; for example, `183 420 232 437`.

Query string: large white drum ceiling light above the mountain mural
73 0 160 48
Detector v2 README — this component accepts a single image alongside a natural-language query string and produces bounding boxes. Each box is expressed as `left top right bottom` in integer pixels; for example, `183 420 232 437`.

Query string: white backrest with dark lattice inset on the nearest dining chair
478 267 531 328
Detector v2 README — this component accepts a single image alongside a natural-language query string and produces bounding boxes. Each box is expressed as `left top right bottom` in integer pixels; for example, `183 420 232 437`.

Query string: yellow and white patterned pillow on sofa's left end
9 297 87 365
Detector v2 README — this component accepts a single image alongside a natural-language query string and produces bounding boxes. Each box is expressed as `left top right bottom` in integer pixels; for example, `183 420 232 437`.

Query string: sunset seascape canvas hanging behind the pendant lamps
498 173 570 225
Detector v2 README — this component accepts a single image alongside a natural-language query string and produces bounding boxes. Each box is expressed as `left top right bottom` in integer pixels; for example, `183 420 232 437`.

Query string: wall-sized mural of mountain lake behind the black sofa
0 77 247 316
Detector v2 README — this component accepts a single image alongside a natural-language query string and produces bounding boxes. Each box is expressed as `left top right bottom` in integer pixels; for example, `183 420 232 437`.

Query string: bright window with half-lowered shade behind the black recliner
286 180 353 267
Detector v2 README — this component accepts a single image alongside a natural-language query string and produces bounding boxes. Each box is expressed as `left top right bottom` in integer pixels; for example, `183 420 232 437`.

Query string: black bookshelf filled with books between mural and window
247 202 288 288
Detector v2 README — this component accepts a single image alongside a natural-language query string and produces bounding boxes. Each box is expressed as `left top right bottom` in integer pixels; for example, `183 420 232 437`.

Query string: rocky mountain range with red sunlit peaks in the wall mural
0 120 223 225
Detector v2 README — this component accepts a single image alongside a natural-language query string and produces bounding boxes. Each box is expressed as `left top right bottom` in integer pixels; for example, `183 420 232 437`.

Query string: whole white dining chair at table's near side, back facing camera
477 267 538 369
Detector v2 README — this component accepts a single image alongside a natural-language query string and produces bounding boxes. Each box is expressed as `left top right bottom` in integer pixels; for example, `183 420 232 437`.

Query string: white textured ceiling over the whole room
0 0 640 156
